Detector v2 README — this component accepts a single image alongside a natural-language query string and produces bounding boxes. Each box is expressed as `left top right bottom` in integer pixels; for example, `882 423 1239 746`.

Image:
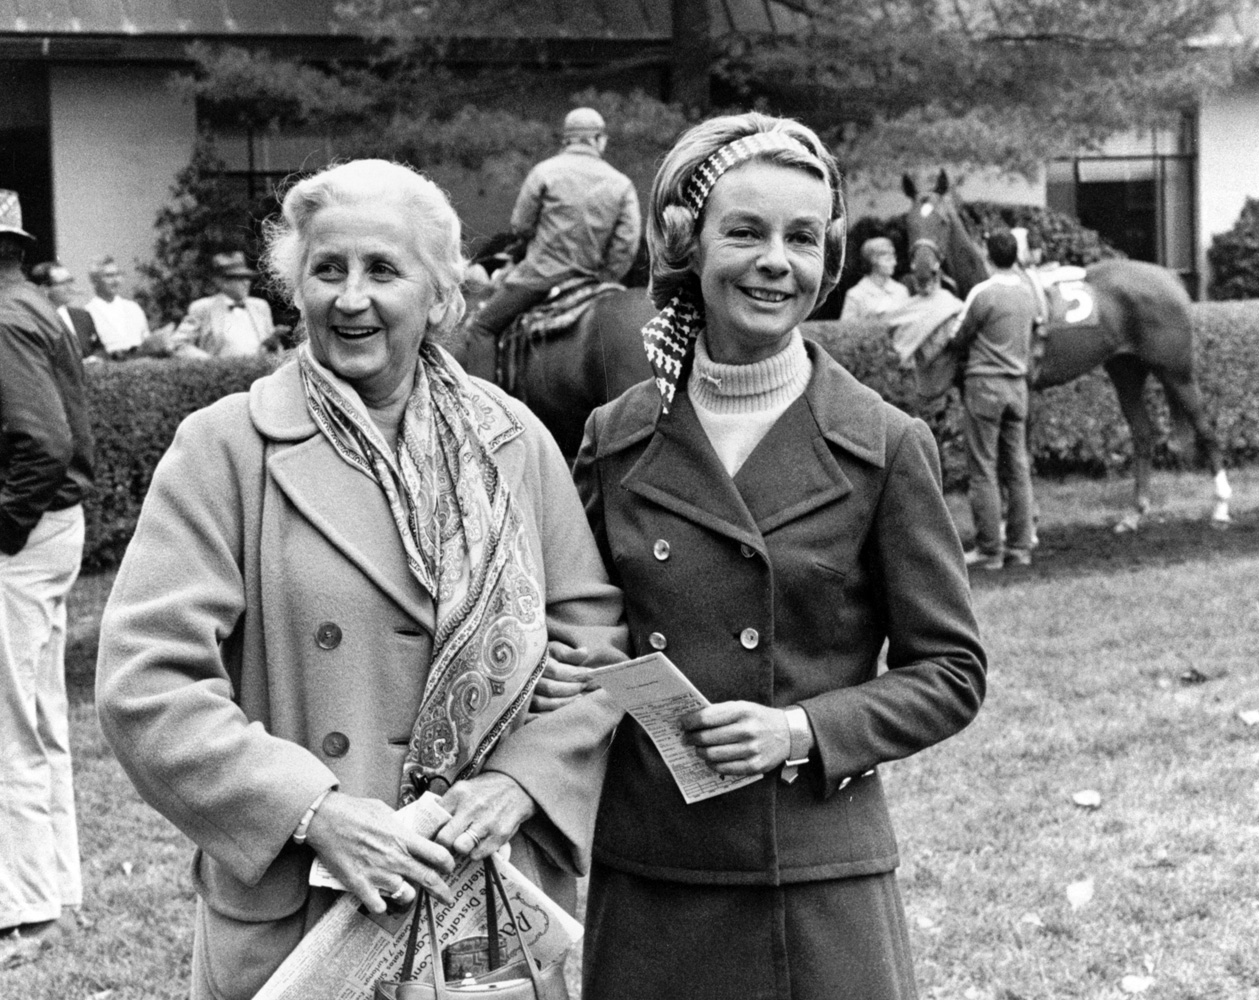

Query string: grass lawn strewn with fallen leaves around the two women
0 470 1259 1000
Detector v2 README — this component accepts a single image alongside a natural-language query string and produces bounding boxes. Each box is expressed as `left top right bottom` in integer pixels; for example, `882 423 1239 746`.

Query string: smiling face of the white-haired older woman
296 199 446 409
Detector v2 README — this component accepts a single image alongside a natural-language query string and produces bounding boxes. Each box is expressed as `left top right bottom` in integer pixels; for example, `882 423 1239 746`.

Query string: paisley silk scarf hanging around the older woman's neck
298 343 546 804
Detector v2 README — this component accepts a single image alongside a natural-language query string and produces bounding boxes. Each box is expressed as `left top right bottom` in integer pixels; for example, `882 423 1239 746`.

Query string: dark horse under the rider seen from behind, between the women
447 280 656 462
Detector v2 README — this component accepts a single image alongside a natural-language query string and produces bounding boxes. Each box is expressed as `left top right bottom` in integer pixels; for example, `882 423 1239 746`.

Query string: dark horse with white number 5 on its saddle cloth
903 170 1233 531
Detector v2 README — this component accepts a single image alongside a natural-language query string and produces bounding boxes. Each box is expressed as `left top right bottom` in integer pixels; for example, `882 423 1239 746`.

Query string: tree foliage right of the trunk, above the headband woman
718 0 1239 178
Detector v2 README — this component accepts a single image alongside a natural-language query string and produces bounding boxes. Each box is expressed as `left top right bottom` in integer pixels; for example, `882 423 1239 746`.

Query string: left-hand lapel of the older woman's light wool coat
267 436 434 631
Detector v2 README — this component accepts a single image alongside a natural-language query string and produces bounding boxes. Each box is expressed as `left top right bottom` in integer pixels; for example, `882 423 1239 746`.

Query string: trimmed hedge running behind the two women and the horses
76 302 1259 571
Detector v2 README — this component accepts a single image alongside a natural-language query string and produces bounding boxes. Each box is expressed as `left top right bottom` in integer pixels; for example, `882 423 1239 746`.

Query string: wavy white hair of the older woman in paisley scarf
262 160 467 332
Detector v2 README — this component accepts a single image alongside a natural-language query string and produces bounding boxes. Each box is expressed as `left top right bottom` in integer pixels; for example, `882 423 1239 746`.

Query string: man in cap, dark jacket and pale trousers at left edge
0 190 92 969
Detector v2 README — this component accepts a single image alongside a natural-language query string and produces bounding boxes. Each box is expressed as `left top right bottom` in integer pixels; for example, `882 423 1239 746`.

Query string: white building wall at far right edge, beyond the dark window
1197 84 1259 288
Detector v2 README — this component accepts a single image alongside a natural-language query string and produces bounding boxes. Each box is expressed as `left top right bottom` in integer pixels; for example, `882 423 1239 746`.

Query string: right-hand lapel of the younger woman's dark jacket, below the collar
734 397 852 534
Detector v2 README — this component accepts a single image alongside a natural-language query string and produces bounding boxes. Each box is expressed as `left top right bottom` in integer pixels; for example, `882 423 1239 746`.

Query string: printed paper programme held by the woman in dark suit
589 652 764 805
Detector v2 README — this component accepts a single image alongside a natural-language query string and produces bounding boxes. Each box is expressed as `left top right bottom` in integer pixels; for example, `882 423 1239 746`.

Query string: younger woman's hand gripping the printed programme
681 702 791 777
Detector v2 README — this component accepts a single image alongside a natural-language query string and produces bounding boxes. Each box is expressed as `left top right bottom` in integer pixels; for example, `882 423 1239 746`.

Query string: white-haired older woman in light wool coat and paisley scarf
98 161 622 997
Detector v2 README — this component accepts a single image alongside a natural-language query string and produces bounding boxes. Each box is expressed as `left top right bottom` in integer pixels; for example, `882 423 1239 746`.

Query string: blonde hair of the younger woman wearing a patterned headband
647 111 845 309
